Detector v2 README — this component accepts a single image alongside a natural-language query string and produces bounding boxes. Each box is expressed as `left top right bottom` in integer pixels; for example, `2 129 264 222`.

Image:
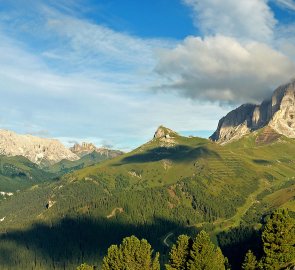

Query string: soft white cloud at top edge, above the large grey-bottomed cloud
183 0 276 41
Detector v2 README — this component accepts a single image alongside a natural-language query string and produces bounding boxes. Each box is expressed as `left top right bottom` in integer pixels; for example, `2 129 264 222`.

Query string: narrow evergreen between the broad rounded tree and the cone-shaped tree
166 235 192 270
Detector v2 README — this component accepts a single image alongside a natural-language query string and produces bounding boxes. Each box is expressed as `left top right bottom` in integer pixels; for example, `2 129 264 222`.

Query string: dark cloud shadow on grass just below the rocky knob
115 145 219 166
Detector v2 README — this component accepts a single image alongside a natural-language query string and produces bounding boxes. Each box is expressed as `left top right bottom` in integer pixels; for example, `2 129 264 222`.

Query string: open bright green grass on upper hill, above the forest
0 129 295 229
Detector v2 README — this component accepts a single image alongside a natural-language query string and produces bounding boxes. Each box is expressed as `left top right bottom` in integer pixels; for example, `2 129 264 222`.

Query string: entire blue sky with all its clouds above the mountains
0 0 295 151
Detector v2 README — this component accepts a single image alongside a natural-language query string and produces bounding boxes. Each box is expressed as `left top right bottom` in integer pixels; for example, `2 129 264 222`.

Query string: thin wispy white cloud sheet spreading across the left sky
0 1 229 150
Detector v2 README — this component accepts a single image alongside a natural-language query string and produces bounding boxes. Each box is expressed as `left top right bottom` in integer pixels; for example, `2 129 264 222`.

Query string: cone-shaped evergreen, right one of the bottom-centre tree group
187 231 226 270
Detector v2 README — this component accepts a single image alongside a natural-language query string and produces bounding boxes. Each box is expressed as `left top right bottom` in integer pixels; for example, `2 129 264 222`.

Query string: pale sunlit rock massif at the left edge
0 129 79 165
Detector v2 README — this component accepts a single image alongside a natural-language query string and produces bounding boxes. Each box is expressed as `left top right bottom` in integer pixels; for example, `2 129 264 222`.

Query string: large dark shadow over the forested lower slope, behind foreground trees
0 217 197 269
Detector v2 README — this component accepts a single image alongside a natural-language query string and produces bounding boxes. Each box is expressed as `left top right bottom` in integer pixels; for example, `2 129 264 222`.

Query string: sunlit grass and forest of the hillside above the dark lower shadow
0 131 295 268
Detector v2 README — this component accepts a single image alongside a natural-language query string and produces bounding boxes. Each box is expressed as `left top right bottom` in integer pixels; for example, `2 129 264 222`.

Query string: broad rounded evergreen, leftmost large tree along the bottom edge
102 236 160 270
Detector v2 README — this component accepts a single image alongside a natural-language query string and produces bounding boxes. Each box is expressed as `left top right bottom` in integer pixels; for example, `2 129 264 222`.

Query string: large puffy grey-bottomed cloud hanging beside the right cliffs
156 36 295 103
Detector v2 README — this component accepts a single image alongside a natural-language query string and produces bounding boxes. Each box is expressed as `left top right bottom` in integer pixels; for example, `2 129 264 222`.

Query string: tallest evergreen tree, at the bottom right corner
262 210 295 269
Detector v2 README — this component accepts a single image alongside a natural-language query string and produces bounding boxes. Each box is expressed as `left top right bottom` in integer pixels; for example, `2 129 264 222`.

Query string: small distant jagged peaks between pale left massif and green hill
70 142 123 158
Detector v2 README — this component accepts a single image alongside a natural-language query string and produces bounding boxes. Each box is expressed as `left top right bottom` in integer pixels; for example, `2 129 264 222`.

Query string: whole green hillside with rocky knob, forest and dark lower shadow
0 127 295 269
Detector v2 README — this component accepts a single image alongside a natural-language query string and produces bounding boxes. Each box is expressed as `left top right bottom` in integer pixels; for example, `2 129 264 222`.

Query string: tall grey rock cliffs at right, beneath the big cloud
210 80 295 144
